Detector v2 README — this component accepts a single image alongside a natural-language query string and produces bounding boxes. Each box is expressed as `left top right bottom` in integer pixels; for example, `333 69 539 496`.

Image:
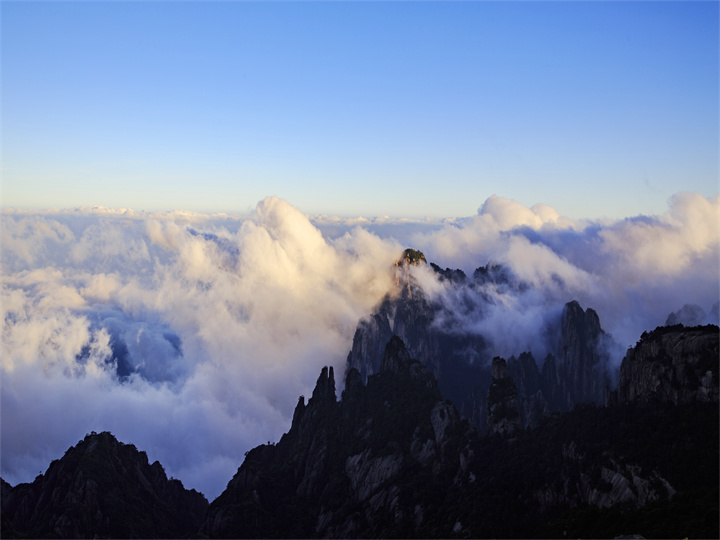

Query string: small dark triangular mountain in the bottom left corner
2 432 208 538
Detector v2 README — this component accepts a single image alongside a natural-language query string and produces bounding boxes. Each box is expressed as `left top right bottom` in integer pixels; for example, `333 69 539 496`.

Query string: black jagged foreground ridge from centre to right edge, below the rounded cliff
201 336 718 538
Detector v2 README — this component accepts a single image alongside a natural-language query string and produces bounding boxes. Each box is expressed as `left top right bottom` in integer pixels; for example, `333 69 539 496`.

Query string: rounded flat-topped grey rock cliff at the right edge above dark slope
618 325 720 404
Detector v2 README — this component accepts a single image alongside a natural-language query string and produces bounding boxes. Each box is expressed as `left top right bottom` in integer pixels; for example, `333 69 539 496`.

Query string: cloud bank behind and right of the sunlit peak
413 193 720 352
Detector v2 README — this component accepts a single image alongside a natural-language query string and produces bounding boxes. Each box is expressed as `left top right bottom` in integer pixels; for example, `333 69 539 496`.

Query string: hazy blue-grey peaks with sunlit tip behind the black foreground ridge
347 249 614 433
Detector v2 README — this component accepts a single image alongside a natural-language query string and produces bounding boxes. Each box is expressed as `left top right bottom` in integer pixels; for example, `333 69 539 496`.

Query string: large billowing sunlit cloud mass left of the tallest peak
2 198 402 497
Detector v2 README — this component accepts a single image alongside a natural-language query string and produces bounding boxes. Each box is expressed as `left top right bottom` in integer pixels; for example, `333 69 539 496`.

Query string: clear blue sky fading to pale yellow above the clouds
0 1 719 218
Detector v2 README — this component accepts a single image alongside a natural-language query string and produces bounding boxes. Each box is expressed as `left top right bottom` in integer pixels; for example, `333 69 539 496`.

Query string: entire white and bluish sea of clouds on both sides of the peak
0 193 720 500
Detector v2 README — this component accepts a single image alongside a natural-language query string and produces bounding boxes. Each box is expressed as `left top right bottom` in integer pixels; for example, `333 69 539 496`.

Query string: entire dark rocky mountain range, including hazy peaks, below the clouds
1 250 720 538
